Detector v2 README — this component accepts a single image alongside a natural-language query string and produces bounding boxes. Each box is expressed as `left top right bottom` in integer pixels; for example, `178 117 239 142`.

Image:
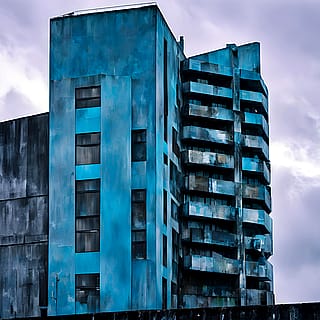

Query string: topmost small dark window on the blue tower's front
75 86 101 109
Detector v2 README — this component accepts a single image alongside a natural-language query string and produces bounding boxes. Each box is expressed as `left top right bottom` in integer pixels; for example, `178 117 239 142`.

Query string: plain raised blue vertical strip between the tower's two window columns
100 76 131 312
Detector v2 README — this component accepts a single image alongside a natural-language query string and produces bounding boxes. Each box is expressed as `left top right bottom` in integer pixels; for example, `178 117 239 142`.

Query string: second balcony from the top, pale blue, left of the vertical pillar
183 81 232 100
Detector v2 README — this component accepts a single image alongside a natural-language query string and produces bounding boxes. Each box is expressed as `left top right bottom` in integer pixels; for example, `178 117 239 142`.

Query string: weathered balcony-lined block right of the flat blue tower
181 43 274 307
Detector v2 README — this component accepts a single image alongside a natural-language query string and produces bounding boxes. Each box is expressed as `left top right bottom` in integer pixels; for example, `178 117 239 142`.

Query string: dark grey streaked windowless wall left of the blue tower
0 113 49 318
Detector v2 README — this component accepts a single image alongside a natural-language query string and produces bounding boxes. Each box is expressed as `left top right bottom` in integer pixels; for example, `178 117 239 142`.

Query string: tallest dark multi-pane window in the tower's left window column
76 179 100 252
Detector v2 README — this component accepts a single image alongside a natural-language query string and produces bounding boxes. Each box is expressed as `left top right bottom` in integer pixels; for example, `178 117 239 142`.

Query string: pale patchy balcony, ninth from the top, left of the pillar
184 253 239 274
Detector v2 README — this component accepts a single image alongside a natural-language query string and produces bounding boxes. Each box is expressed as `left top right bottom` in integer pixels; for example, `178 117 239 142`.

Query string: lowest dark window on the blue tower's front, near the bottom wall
76 274 100 312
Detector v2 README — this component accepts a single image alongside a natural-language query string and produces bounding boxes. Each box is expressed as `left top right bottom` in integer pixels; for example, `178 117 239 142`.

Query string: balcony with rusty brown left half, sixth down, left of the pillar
185 175 234 196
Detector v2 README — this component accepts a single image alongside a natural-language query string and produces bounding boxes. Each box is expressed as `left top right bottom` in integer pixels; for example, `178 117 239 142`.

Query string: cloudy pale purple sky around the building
0 0 320 303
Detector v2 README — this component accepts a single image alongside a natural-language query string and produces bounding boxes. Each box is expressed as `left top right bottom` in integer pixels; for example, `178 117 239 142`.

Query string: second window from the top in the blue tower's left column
76 132 100 165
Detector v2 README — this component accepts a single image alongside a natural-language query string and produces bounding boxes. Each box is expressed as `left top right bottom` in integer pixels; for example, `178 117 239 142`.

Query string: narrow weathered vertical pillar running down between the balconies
229 45 246 306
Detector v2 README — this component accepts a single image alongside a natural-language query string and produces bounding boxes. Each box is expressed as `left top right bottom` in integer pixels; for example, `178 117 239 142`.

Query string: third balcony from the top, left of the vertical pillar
183 103 233 121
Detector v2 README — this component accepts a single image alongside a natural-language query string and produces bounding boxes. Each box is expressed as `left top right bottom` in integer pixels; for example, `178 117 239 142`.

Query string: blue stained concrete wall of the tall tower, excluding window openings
48 6 182 315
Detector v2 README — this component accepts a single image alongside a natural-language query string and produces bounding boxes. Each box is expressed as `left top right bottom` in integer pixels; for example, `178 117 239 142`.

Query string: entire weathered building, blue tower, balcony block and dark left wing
0 5 274 318
